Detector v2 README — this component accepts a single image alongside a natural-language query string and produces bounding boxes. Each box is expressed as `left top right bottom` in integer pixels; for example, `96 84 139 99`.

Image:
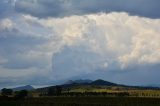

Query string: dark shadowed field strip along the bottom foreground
0 97 160 106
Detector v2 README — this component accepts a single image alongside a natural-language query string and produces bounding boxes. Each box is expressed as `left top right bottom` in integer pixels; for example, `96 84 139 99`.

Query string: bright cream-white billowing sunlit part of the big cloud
36 12 160 67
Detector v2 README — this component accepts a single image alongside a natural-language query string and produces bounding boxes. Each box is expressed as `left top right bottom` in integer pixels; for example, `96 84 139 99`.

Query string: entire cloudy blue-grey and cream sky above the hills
0 0 160 88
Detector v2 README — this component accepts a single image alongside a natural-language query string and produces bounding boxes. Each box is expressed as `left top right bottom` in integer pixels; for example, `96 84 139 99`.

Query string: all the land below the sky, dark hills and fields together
0 80 160 106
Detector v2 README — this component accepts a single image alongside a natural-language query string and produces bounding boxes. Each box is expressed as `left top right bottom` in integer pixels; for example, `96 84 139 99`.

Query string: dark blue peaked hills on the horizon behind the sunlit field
36 79 160 92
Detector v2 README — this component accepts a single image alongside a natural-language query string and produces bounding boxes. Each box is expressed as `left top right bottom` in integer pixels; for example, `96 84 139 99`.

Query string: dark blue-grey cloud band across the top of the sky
15 0 160 18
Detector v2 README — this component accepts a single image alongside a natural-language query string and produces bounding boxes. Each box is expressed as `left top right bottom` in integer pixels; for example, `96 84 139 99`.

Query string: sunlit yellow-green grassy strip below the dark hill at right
66 86 160 98
